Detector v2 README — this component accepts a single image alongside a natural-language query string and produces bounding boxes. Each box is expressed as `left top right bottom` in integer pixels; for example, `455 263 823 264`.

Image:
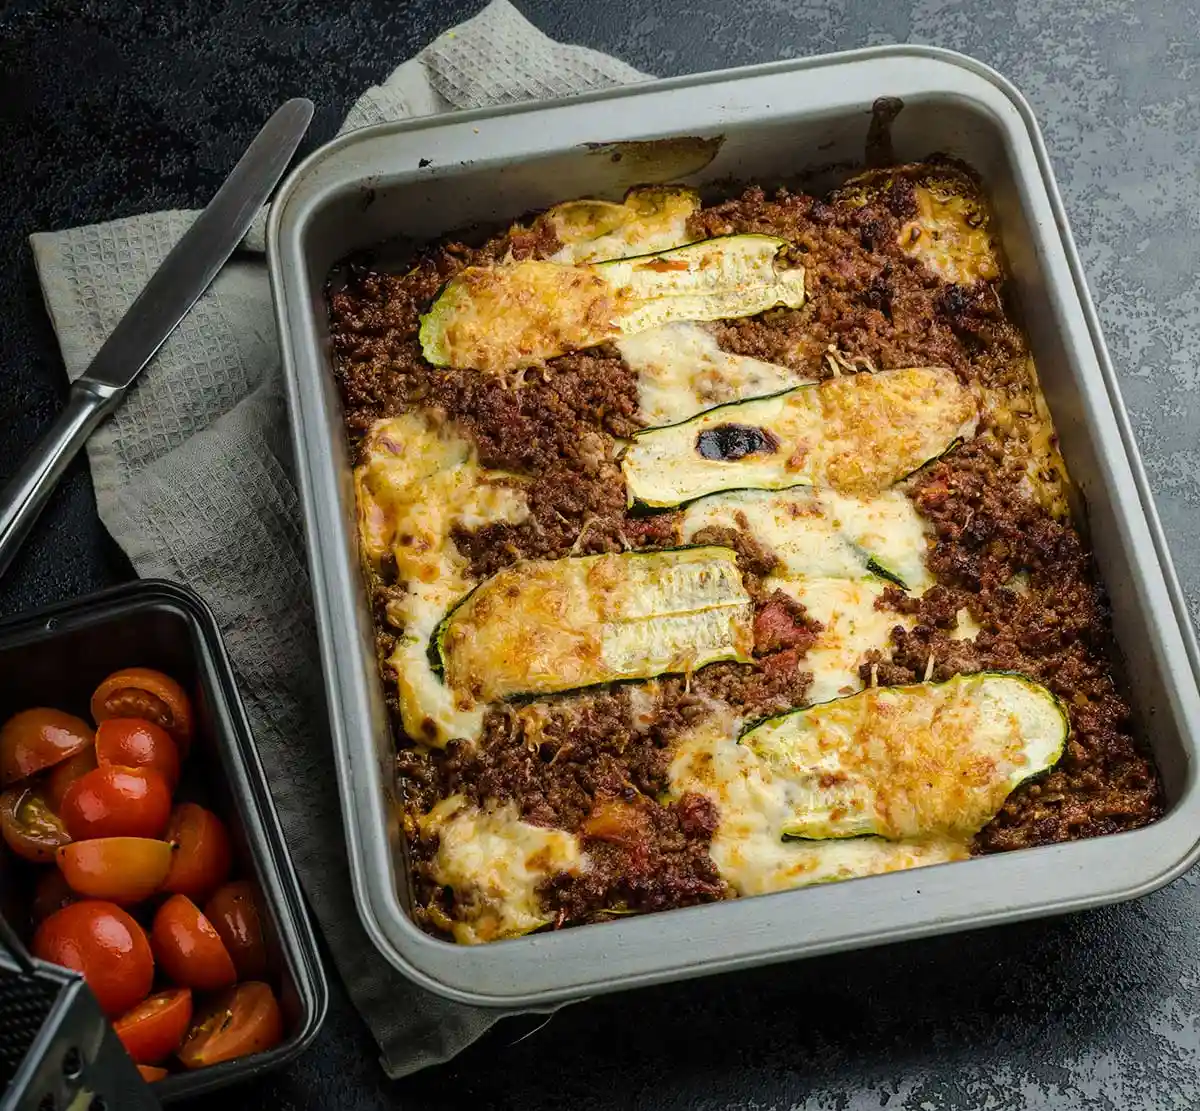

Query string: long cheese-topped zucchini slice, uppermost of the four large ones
420 235 804 372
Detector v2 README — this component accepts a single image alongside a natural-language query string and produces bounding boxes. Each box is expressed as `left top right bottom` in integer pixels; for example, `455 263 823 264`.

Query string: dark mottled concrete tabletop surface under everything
0 0 1200 1111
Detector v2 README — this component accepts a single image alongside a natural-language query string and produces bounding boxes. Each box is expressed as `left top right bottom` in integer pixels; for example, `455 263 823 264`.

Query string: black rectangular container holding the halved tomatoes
0 579 328 1103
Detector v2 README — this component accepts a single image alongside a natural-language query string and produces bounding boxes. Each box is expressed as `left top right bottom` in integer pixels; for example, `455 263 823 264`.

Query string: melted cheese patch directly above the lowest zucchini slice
764 577 916 702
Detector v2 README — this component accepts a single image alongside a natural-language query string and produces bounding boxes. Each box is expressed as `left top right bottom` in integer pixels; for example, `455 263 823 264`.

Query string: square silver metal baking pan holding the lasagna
269 47 1200 1007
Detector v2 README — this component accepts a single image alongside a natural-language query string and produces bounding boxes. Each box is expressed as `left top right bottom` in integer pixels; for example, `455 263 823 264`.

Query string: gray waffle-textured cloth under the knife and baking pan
31 0 644 1076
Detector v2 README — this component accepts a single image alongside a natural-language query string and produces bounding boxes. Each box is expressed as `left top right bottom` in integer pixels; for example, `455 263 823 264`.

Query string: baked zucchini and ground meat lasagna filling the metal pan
329 160 1163 944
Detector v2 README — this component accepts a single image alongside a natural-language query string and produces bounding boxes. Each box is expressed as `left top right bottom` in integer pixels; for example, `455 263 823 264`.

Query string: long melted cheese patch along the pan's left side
354 412 529 746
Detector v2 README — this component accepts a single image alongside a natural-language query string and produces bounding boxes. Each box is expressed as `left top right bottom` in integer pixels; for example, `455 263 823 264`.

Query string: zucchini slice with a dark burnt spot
622 367 979 510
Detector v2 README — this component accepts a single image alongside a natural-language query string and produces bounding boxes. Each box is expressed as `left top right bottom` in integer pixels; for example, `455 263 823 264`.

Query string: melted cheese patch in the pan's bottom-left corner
420 795 590 944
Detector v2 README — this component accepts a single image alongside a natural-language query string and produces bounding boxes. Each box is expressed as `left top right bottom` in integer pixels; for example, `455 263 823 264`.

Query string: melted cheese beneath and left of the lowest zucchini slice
668 714 968 895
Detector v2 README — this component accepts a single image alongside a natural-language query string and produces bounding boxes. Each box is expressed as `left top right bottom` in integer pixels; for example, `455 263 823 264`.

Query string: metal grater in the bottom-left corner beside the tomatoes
0 917 160 1111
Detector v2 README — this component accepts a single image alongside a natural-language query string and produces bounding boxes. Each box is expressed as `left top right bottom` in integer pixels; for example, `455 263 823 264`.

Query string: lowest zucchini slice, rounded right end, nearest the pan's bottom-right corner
739 672 1070 841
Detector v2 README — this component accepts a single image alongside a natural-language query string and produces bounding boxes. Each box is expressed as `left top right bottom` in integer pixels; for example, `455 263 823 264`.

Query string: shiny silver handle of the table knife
0 380 122 575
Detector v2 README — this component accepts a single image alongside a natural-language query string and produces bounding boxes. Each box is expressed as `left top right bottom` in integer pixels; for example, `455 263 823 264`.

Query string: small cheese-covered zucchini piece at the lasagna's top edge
539 185 700 264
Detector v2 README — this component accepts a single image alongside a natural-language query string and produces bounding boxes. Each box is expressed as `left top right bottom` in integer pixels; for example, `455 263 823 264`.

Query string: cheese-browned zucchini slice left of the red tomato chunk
431 546 754 702
